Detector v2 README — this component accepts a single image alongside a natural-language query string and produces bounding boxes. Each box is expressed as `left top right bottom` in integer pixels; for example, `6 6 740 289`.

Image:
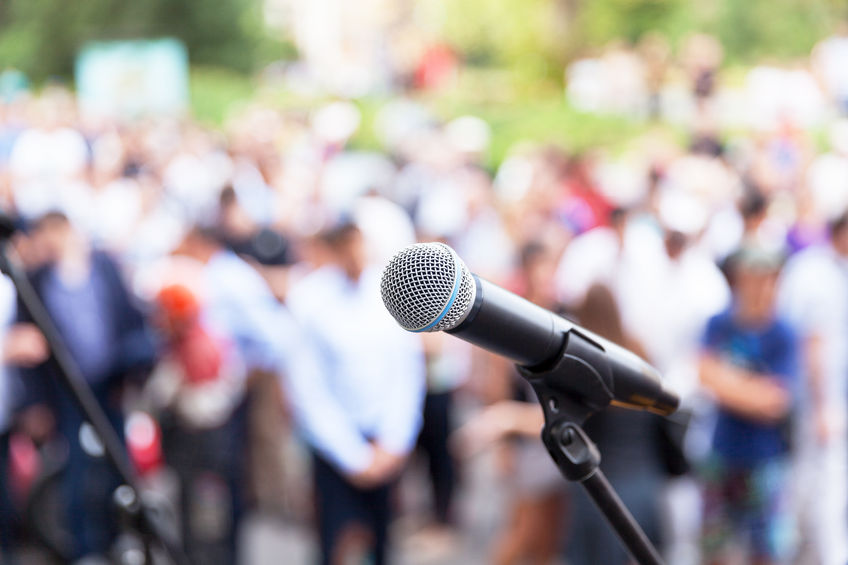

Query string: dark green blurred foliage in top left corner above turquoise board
0 0 290 81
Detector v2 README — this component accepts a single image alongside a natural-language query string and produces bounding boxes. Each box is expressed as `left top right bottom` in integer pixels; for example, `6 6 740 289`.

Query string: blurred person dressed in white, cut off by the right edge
778 212 848 565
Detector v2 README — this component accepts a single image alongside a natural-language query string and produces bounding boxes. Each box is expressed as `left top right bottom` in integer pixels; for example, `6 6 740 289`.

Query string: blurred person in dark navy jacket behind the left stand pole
10 212 155 560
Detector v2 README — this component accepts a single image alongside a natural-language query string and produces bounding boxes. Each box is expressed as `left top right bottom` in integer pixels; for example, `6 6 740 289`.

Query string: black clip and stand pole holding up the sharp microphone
518 330 663 565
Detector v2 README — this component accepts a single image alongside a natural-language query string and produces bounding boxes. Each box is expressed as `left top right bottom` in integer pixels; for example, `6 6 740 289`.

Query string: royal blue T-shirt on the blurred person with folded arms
703 307 798 464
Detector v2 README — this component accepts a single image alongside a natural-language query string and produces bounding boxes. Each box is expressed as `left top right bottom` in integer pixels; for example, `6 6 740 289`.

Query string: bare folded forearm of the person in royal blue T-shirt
699 352 791 424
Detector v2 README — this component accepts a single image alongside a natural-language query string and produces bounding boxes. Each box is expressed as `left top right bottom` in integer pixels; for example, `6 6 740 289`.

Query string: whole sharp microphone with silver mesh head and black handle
380 243 680 416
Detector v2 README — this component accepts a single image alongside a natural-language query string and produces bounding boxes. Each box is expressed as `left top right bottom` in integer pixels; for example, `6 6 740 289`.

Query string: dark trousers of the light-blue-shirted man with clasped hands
312 452 393 565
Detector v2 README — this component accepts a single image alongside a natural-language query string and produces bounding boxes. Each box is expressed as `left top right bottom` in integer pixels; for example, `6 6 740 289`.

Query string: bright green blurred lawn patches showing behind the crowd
186 67 652 168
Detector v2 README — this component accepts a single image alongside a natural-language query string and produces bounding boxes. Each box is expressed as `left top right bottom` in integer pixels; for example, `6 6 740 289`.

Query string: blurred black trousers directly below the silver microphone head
418 391 456 524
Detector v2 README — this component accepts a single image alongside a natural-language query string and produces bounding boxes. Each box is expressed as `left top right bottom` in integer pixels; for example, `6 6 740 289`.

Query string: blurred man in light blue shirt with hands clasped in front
286 223 425 565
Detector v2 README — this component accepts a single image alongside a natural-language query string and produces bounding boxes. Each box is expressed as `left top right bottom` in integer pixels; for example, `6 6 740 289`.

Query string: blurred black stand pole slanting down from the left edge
0 226 190 565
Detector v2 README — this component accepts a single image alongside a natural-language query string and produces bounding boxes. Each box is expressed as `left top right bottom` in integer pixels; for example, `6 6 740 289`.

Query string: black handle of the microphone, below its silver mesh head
446 275 679 415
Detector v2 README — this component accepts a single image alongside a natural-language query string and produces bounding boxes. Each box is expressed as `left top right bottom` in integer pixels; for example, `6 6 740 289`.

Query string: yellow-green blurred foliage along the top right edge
442 0 848 80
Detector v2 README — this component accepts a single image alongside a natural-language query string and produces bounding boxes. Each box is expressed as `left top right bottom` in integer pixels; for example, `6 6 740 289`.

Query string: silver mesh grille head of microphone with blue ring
380 243 476 331
